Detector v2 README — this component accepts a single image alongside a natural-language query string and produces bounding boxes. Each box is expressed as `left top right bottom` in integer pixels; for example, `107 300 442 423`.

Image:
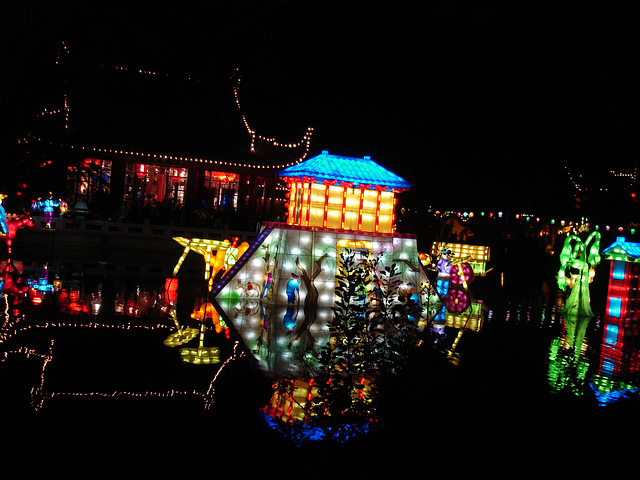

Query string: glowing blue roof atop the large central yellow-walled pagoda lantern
280 150 411 191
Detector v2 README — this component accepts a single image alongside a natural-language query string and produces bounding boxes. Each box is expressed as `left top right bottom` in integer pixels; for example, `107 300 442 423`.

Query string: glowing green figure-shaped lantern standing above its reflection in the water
558 232 600 317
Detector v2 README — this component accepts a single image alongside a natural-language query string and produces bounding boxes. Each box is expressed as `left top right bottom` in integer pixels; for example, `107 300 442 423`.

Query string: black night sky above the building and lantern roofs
3 0 640 212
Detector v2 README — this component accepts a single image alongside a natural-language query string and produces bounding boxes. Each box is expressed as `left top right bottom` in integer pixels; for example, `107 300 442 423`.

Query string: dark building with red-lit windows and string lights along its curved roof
20 47 312 224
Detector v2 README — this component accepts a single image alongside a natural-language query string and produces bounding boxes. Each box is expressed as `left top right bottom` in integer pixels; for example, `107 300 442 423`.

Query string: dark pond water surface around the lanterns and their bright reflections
0 255 640 478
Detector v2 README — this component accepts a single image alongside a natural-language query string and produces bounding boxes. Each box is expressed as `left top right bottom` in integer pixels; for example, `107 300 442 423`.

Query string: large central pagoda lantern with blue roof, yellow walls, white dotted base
211 151 428 374
